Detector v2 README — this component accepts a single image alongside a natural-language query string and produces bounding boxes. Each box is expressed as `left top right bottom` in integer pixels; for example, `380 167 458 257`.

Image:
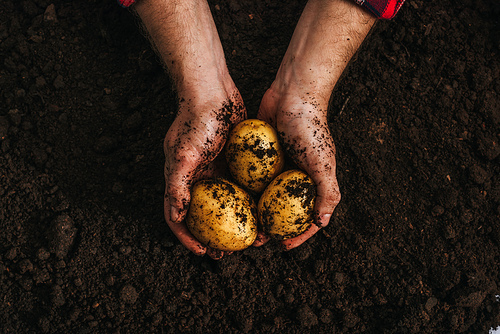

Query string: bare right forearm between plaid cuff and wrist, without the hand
272 0 376 104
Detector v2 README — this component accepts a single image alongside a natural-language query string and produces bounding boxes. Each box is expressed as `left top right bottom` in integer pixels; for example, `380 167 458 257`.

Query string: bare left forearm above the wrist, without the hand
134 0 233 95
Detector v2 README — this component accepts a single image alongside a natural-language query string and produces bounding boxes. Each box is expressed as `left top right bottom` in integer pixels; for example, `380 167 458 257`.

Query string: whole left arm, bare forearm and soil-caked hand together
134 0 250 258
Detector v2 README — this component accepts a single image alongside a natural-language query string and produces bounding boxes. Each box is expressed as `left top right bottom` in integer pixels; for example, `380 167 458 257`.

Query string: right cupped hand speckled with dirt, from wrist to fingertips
254 88 340 250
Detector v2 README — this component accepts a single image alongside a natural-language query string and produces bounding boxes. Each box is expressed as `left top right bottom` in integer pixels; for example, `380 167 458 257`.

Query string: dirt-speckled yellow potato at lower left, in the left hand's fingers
186 178 257 251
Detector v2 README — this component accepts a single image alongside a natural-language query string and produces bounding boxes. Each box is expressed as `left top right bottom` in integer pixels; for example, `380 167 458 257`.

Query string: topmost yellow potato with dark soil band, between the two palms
225 119 285 194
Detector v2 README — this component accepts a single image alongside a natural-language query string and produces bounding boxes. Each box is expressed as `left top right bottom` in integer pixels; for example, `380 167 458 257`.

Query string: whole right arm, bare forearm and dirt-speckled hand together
255 0 376 249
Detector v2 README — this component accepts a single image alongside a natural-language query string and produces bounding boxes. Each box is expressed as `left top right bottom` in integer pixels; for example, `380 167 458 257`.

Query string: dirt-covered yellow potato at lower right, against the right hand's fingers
258 170 316 240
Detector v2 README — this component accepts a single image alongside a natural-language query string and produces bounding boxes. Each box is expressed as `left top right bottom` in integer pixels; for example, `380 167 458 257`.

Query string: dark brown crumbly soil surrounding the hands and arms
0 0 500 333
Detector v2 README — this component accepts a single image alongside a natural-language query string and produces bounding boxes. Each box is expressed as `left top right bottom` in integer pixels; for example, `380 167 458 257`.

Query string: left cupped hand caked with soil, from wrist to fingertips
163 88 246 259
